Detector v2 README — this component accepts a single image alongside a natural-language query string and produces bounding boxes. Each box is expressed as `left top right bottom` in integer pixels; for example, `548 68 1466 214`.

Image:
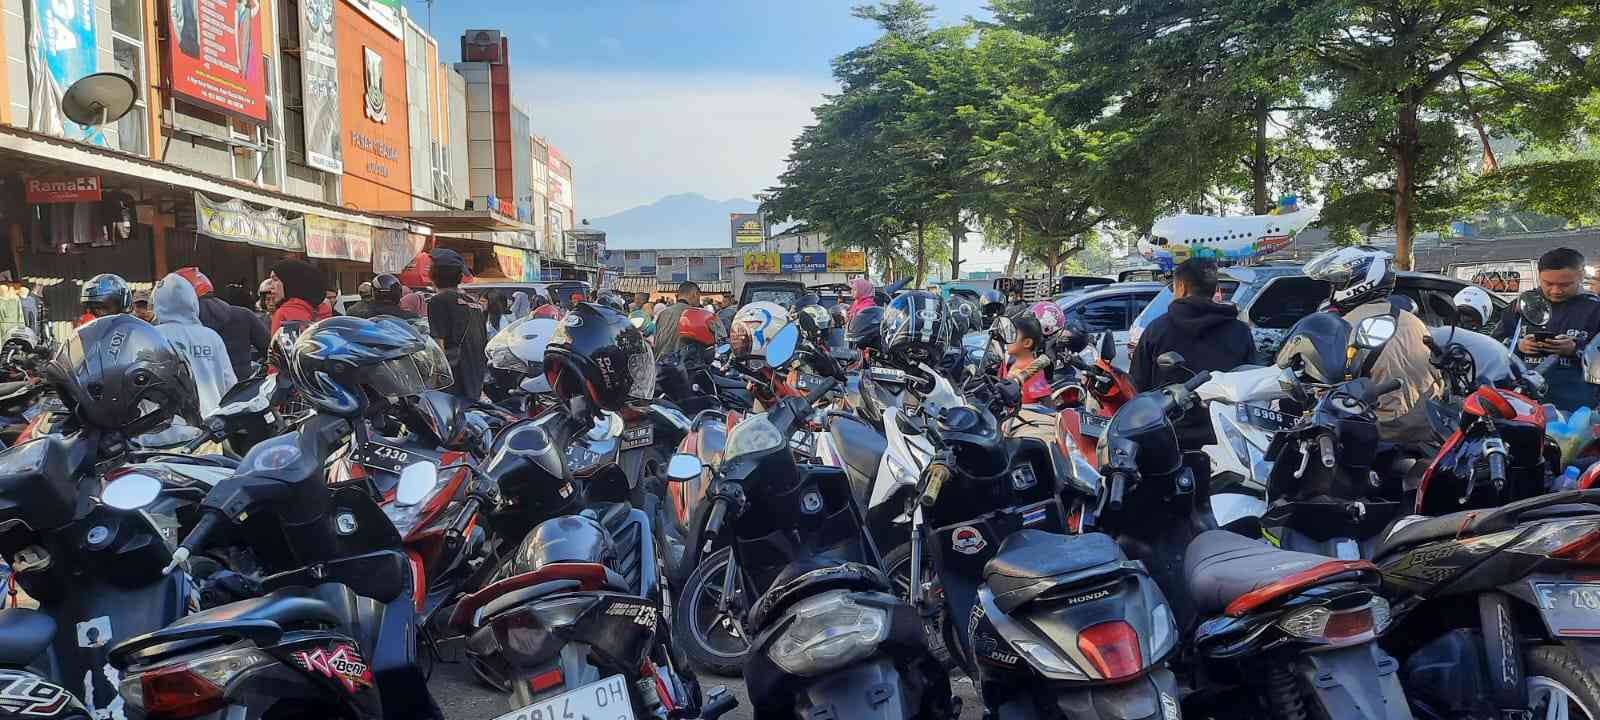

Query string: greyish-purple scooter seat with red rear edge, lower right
1184 530 1378 614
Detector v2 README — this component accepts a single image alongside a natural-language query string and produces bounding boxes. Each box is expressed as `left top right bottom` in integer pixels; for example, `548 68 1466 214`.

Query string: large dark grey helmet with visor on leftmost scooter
43 314 200 437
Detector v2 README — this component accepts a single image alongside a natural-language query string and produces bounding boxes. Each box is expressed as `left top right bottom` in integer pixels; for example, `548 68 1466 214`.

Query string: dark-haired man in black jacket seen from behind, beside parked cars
1128 259 1256 450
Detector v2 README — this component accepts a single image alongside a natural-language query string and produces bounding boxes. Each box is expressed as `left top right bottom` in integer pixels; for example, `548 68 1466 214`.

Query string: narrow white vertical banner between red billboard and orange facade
299 0 344 173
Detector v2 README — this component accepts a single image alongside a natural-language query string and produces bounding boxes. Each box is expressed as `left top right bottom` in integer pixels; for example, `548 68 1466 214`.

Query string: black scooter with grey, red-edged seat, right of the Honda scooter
1085 363 1411 718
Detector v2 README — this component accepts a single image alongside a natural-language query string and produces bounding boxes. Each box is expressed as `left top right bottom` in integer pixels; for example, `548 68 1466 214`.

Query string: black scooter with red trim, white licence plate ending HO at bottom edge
450 400 713 718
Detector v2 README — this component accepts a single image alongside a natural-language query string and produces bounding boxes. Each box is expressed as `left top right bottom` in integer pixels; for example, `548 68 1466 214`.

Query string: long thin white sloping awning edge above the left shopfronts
0 125 410 230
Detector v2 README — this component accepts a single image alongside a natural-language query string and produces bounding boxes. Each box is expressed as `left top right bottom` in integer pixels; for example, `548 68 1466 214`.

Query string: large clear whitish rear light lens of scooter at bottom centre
768 590 890 677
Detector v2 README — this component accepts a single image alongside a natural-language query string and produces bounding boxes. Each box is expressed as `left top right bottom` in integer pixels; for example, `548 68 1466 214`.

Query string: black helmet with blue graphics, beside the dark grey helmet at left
285 315 451 418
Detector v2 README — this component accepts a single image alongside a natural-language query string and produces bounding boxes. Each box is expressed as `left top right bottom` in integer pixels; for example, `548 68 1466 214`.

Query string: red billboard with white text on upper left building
166 0 267 123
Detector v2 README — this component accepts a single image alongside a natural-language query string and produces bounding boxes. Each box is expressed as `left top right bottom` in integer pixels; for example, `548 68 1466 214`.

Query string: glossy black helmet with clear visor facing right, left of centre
544 302 656 413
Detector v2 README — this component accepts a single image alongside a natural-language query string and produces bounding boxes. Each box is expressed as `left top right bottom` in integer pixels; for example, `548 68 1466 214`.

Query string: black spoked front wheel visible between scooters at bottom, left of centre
674 547 750 677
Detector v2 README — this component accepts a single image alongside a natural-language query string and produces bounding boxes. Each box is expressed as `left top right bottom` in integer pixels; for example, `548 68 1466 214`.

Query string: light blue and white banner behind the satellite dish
32 0 106 146
